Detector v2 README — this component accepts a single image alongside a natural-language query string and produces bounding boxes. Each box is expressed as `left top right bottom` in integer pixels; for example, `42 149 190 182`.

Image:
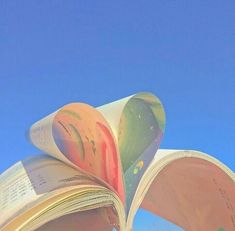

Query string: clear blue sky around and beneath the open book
0 0 235 231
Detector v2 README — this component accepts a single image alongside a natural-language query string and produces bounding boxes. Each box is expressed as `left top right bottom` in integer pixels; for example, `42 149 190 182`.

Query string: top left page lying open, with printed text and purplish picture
0 155 105 227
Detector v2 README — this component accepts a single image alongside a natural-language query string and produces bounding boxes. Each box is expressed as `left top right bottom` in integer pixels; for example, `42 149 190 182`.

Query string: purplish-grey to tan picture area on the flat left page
22 155 102 194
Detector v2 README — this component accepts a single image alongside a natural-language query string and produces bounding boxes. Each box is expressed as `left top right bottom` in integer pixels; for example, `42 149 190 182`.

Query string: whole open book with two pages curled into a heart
0 93 235 231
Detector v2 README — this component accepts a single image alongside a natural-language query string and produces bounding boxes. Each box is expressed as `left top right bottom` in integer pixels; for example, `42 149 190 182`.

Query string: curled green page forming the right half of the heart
97 92 165 212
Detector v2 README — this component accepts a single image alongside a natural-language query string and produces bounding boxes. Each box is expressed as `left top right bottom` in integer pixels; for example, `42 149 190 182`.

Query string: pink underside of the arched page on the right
141 158 235 231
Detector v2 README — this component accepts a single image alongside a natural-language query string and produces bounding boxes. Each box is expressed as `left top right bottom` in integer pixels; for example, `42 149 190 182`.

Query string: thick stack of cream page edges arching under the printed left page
1 185 125 231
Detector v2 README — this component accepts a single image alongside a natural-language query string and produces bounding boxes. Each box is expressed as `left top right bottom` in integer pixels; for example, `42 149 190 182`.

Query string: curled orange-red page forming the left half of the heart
29 103 125 203
